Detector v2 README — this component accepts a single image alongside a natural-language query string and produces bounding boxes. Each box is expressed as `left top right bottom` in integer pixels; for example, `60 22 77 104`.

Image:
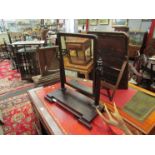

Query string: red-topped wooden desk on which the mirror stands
29 78 155 134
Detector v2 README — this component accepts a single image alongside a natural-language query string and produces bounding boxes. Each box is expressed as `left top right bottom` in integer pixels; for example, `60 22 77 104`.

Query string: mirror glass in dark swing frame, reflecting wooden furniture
60 34 94 94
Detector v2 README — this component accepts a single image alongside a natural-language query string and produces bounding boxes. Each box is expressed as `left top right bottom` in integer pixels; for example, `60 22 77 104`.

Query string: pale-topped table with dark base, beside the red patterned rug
12 40 44 80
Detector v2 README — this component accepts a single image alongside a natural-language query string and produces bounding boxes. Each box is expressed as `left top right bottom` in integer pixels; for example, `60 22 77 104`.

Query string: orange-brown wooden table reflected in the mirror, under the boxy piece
64 57 93 79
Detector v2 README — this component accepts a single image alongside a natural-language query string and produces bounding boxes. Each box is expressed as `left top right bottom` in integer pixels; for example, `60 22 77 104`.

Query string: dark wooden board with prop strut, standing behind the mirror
88 32 128 100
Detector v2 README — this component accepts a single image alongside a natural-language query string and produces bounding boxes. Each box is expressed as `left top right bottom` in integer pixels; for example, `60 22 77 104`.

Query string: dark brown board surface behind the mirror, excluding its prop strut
88 31 128 89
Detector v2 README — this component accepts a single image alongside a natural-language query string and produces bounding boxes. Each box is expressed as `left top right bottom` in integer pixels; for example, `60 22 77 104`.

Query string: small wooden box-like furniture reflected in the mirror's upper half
62 37 92 65
